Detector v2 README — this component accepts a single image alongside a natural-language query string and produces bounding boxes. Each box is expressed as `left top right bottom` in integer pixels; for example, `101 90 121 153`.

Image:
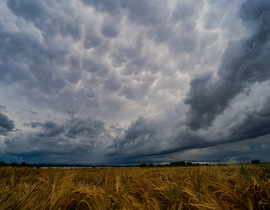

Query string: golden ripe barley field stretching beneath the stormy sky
0 165 270 210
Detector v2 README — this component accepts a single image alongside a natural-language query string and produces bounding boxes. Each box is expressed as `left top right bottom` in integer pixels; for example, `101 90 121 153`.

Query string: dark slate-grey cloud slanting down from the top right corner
185 1 270 130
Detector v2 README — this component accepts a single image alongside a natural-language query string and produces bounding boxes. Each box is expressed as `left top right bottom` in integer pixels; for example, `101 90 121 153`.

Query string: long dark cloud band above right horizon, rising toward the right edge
138 96 270 157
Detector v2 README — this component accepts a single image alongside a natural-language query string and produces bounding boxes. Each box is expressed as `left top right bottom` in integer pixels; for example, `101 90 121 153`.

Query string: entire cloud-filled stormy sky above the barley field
0 0 270 165
